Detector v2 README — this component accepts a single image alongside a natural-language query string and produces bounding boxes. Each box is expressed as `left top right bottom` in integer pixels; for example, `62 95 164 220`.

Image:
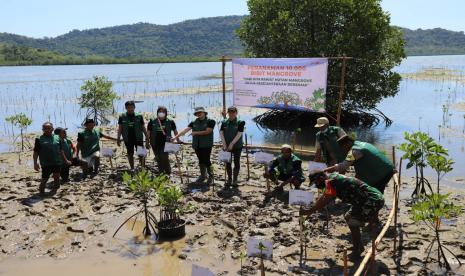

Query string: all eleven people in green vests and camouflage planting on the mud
33 101 395 255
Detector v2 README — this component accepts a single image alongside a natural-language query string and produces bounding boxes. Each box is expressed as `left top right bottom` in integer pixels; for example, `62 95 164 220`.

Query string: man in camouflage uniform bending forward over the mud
300 171 384 259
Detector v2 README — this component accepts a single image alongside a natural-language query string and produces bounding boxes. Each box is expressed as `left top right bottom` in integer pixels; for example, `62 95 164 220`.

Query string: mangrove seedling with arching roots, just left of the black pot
113 169 169 237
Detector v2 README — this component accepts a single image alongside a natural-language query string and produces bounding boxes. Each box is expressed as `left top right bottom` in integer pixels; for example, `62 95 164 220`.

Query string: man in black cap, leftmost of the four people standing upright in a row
116 101 149 170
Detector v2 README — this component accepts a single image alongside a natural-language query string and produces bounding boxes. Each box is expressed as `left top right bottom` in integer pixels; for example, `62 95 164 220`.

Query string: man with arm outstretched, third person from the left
74 119 117 177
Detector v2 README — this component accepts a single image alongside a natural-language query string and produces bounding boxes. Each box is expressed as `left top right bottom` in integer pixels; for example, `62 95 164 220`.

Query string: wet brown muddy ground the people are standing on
0 143 465 276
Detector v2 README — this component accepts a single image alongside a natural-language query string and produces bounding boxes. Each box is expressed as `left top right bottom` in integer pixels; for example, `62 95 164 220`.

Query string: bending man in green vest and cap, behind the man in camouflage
325 135 395 194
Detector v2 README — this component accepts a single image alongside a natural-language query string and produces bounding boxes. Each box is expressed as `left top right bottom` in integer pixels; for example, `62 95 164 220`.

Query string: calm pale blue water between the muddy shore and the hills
0 56 465 181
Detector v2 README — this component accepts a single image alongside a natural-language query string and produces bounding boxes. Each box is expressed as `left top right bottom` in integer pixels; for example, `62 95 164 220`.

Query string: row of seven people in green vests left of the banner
33 101 245 193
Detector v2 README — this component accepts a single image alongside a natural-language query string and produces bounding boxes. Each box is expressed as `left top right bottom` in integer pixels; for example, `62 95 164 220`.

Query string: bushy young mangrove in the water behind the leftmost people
78 76 119 125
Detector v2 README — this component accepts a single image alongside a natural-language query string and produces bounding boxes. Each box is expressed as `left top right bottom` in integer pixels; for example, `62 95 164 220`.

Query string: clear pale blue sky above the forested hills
0 0 465 37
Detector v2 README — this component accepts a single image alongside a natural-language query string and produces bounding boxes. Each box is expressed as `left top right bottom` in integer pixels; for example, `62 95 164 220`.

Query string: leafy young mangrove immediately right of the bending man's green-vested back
399 131 437 198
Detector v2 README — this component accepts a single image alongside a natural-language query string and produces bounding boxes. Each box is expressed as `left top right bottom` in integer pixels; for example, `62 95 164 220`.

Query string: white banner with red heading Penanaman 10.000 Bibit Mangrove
232 58 328 112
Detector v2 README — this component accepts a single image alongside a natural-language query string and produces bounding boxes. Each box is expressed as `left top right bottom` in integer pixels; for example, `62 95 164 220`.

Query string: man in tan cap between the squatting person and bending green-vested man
314 117 346 166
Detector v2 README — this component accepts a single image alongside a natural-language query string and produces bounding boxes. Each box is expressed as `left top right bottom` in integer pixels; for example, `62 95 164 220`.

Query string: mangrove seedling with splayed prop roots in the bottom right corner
411 193 462 270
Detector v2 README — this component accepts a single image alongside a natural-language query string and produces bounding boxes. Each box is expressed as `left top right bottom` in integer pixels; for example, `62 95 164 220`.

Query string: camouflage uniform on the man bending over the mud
325 173 384 227
